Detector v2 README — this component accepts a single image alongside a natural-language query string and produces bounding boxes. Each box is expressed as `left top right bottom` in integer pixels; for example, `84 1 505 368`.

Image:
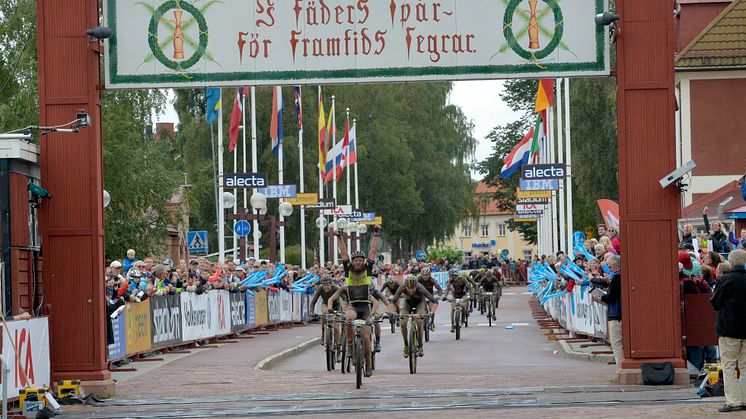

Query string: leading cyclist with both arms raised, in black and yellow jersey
327 226 385 377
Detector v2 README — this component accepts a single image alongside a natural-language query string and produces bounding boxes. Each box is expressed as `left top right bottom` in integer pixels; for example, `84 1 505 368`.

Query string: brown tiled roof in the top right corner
676 0 746 70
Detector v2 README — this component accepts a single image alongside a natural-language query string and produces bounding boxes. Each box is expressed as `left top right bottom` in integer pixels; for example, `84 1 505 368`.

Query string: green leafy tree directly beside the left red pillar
102 90 182 259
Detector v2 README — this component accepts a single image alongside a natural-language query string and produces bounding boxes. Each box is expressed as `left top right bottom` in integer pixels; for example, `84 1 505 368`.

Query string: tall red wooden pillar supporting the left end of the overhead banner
37 0 113 394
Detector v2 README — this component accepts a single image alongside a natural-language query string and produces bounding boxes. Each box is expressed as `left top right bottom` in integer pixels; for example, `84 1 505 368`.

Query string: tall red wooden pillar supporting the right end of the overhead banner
616 0 688 384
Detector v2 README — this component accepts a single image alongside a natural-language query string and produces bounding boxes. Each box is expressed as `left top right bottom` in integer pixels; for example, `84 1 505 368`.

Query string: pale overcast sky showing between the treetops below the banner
156 80 518 180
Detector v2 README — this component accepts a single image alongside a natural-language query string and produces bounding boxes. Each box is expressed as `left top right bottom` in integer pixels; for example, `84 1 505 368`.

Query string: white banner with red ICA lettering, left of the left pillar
2 317 51 397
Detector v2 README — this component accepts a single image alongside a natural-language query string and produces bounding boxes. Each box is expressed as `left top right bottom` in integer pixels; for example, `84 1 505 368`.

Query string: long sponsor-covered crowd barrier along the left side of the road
109 290 312 361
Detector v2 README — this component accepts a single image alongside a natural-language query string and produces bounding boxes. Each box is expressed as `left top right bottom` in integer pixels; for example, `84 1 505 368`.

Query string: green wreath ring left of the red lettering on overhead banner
148 0 207 71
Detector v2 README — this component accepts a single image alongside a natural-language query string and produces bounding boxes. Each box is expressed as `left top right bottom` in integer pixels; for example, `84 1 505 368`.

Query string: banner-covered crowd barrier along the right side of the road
544 285 608 339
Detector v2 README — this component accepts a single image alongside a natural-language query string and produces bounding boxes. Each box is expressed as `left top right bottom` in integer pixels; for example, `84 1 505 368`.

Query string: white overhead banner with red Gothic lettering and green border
104 0 609 88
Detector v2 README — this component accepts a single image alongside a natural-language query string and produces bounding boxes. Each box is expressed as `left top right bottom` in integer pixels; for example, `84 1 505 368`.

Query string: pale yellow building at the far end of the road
449 182 537 259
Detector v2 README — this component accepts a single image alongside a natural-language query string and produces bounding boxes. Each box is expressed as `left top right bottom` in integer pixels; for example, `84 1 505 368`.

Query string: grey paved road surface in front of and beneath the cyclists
64 288 723 418
